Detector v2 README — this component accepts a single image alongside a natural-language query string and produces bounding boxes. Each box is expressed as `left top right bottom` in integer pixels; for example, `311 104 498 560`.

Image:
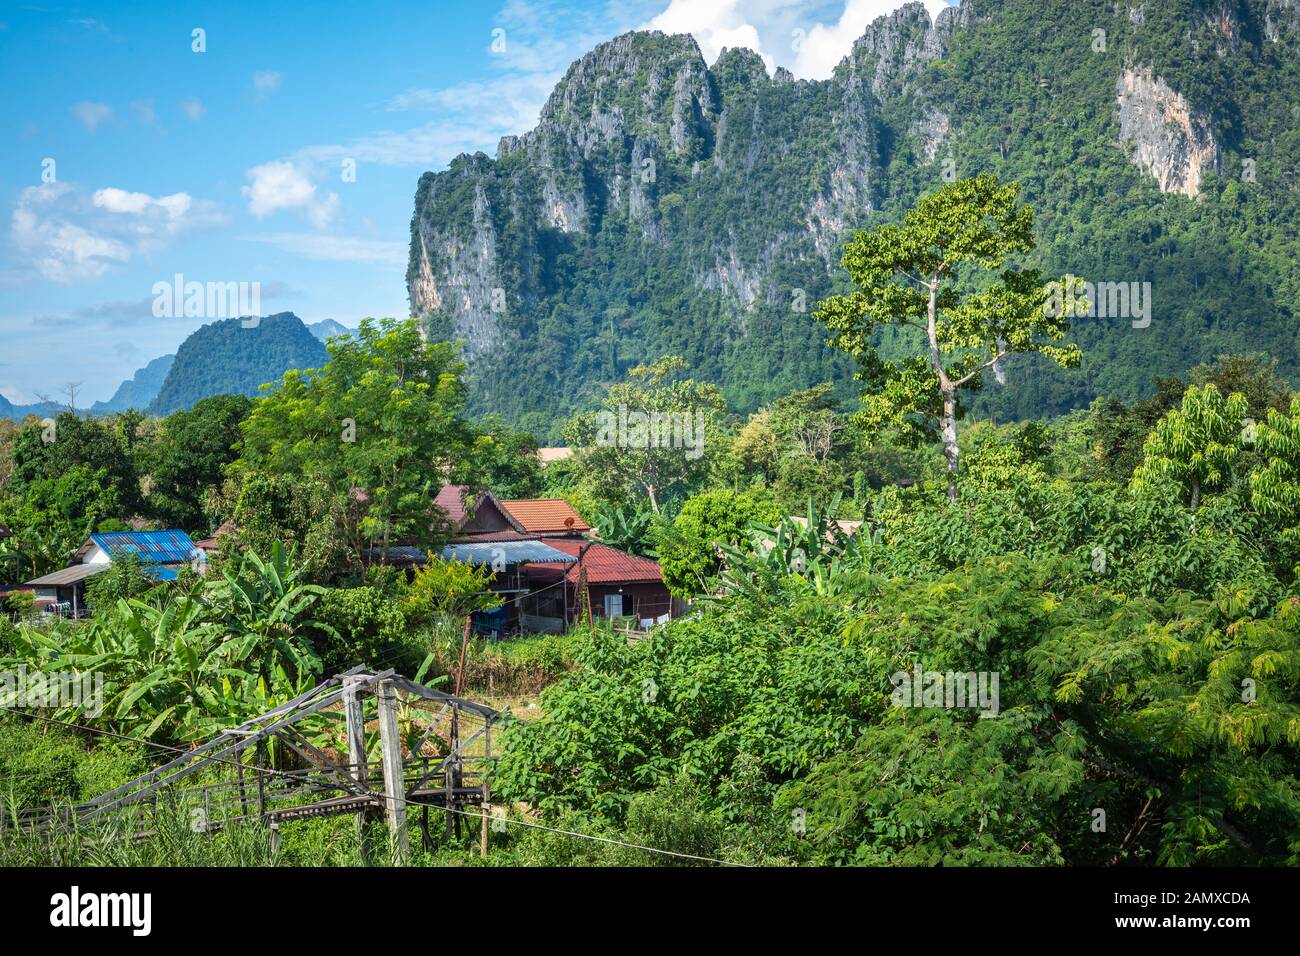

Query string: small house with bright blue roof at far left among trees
23 531 208 618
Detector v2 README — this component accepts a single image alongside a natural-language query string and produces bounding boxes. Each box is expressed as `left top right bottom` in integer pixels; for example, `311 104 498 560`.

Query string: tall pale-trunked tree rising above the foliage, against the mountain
815 173 1082 498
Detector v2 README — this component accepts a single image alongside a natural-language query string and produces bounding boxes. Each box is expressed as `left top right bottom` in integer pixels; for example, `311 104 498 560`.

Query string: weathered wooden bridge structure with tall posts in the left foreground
17 667 507 865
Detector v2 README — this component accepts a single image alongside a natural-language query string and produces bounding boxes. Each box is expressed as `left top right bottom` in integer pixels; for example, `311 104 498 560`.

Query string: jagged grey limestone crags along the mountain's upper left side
407 4 962 362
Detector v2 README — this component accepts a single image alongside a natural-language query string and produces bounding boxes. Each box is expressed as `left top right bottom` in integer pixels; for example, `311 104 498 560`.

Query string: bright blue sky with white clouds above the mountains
0 0 943 406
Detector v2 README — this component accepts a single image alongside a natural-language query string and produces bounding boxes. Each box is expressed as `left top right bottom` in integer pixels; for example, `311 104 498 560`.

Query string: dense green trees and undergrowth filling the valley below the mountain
0 162 1300 865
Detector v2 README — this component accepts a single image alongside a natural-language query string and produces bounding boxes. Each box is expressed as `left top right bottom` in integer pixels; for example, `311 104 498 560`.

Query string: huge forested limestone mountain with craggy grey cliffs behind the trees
407 0 1300 434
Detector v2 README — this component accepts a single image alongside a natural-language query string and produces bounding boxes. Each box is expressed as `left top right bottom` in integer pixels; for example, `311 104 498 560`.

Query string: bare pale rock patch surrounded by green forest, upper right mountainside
1115 66 1219 199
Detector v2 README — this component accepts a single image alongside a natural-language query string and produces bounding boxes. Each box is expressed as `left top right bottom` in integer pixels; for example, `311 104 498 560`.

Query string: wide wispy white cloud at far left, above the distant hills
9 183 222 282
